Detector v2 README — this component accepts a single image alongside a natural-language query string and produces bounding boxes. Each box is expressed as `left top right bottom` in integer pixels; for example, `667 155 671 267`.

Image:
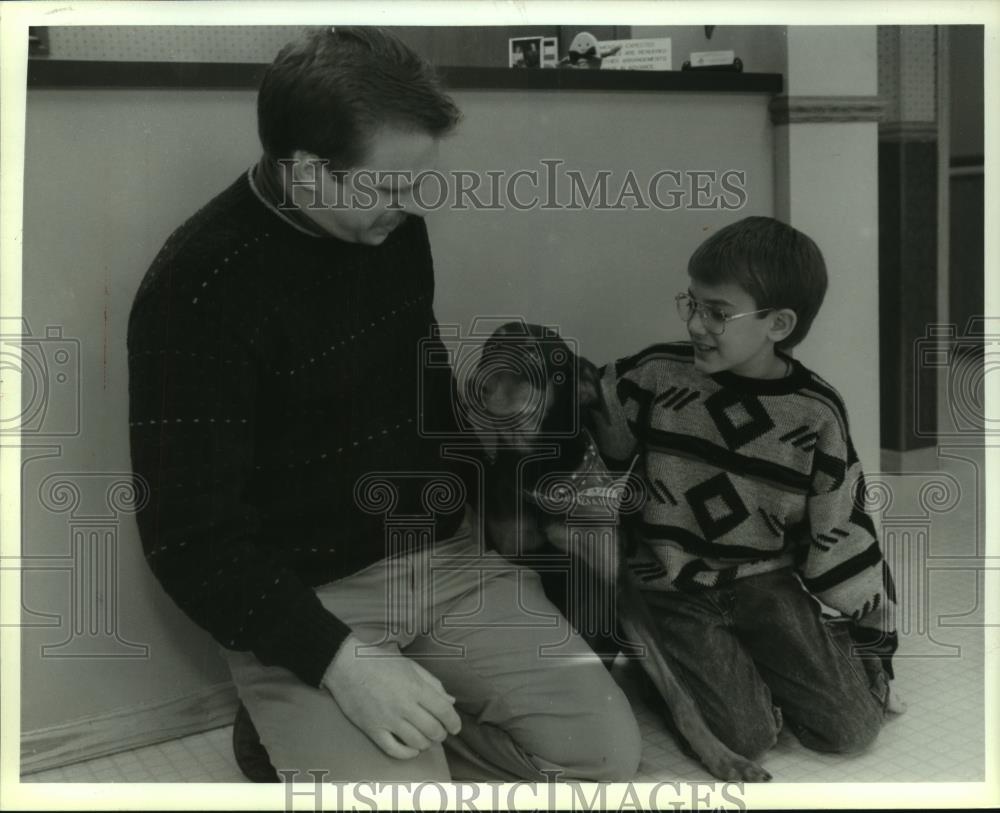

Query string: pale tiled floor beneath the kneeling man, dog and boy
23 451 984 782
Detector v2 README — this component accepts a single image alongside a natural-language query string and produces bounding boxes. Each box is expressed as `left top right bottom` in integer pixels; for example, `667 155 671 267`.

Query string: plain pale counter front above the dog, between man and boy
428 91 773 361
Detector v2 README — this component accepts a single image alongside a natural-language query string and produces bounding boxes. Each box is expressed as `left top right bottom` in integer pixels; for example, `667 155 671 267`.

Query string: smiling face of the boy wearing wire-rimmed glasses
687 279 795 378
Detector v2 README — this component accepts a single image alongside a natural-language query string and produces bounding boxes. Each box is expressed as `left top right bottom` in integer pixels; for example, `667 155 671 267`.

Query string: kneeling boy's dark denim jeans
643 568 888 759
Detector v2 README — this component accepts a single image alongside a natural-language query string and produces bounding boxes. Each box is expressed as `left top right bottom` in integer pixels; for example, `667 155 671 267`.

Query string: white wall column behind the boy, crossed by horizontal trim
775 26 881 473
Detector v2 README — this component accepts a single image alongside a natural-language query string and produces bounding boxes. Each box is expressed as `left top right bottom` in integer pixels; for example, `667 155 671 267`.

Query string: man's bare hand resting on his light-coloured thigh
323 635 462 759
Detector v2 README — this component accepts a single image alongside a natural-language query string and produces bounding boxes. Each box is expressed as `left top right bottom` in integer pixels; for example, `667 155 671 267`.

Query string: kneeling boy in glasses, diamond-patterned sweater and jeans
599 217 902 759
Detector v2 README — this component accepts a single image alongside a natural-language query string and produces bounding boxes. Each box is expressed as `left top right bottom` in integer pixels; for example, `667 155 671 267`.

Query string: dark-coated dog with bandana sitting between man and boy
466 321 771 782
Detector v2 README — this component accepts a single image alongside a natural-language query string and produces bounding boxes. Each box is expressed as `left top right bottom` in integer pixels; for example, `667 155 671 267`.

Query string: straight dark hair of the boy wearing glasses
688 217 826 350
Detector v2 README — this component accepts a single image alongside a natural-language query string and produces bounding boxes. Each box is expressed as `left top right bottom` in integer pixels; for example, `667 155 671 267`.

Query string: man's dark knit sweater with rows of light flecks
128 170 462 686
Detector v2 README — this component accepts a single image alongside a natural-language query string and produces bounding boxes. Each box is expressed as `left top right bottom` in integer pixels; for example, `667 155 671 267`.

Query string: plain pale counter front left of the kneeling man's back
22 90 258 731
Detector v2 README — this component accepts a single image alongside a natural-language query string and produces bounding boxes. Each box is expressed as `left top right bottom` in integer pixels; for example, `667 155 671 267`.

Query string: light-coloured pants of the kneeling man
225 513 641 782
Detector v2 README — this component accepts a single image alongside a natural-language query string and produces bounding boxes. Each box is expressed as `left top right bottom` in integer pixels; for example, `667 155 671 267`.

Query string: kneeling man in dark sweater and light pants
128 28 640 781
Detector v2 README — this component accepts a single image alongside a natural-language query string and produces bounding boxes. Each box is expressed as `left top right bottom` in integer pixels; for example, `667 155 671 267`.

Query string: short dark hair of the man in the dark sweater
257 26 460 170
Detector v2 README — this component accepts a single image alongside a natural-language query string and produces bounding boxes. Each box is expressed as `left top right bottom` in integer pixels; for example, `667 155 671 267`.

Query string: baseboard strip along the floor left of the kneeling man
21 683 239 775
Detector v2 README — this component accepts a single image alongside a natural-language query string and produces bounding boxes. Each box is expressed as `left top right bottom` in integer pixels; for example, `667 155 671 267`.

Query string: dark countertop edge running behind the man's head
28 59 783 94
